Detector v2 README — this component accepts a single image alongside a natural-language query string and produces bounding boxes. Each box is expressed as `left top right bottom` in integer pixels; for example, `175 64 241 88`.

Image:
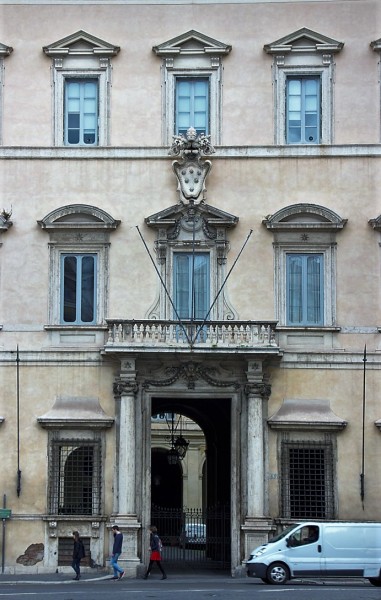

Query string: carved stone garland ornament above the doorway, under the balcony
143 361 240 390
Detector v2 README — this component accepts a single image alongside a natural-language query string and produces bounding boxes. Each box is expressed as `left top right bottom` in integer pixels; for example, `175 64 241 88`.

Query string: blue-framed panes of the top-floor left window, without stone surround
64 79 98 146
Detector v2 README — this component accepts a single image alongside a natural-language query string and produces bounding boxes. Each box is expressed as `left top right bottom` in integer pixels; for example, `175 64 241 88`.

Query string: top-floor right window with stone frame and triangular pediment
264 28 344 144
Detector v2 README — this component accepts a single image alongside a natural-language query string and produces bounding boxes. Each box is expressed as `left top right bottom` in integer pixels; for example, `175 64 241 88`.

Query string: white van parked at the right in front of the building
246 522 381 586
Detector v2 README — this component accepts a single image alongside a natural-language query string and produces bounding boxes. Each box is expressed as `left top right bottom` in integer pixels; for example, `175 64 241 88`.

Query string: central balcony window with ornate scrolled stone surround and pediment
145 203 238 321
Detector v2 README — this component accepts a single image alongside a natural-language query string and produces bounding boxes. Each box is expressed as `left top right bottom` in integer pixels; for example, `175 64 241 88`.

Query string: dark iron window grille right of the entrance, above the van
281 442 334 519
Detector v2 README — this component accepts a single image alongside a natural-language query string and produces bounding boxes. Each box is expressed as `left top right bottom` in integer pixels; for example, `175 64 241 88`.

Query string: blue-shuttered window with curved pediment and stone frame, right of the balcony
263 204 346 327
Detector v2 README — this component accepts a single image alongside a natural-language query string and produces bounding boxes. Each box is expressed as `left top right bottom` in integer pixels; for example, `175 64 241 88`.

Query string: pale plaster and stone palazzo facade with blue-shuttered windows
0 0 381 577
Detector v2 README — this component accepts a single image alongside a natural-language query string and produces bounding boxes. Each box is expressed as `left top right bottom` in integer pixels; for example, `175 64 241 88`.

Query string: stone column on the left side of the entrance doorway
112 358 141 577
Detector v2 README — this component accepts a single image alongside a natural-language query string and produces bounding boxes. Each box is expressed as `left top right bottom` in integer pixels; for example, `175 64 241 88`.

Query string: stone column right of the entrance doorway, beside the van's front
242 360 271 558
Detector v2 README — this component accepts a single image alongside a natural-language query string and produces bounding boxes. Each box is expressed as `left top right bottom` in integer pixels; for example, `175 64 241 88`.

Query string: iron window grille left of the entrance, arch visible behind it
49 440 102 515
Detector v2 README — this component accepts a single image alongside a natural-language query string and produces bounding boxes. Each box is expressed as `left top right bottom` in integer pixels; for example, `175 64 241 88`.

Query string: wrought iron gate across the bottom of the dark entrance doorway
151 506 230 569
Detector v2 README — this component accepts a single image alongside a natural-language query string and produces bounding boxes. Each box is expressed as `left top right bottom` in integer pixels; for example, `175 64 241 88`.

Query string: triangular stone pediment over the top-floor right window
264 27 344 54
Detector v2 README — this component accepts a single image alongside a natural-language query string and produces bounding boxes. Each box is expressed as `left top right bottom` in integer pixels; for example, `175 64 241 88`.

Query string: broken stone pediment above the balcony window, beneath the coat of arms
145 203 238 228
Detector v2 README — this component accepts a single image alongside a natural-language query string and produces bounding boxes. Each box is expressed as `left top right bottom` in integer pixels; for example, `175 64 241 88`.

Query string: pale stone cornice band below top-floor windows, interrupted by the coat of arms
0 144 381 161
